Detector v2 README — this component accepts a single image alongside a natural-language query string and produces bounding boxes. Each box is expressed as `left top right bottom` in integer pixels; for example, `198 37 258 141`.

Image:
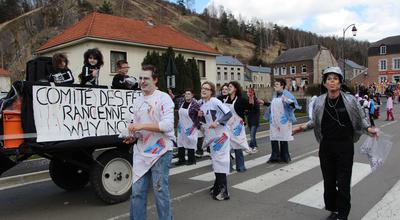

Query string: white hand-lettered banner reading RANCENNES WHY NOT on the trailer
32 86 141 142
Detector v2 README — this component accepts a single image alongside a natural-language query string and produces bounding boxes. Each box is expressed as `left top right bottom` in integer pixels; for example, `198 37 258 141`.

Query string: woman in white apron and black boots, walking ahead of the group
198 82 232 201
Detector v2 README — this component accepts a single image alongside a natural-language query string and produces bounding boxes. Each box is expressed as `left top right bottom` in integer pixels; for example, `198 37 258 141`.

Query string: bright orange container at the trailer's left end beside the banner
3 110 24 149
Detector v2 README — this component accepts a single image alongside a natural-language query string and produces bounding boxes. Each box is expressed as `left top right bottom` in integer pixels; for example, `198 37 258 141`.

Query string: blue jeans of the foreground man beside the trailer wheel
130 151 172 220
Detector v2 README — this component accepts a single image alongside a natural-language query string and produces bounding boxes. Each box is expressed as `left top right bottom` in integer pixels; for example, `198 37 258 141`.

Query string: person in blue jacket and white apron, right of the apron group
268 79 301 163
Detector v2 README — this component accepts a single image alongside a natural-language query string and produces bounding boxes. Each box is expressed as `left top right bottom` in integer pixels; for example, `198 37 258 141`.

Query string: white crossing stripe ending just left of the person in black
233 156 319 193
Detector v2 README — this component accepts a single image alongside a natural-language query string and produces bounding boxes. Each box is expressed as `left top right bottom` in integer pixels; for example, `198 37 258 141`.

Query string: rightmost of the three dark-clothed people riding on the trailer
111 60 138 90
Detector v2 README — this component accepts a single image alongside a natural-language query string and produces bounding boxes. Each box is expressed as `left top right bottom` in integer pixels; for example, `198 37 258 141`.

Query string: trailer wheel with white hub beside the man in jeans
90 149 132 204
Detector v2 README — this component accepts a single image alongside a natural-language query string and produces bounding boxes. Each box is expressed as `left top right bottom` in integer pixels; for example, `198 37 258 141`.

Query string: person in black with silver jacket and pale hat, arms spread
293 67 376 219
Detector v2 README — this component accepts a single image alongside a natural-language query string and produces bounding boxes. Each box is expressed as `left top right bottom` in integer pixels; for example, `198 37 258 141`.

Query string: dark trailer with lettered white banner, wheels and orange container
0 81 141 204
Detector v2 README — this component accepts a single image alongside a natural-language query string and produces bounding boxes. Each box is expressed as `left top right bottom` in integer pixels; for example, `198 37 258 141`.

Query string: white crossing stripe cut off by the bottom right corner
361 181 400 220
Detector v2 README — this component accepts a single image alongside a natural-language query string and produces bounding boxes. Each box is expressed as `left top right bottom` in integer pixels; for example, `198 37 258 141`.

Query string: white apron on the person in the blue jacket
270 97 293 141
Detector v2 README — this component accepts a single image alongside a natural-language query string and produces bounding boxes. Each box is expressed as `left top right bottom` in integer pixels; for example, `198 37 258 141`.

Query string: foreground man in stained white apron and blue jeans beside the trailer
124 65 176 220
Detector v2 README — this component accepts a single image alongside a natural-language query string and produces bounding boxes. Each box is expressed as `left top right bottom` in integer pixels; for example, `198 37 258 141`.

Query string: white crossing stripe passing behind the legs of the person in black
289 162 371 209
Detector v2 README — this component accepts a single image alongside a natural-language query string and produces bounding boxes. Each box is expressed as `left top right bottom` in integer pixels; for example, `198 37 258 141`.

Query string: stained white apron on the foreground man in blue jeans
133 100 173 183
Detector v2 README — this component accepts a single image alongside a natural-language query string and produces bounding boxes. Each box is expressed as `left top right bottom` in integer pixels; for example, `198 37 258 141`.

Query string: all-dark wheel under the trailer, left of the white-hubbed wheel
49 160 89 191
